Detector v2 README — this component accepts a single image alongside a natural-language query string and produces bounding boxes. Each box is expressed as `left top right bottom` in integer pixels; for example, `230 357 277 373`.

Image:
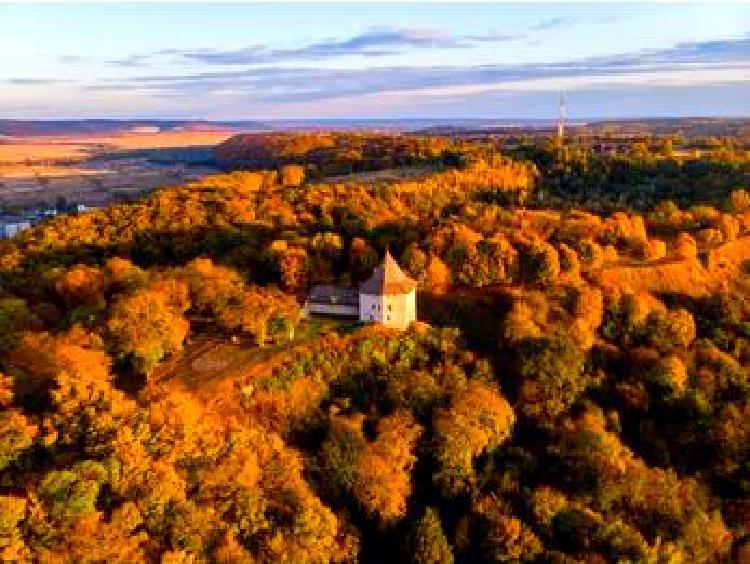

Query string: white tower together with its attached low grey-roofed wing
304 252 424 329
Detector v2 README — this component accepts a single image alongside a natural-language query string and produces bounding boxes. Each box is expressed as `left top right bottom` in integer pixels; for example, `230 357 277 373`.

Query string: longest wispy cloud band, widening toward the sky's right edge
89 38 750 107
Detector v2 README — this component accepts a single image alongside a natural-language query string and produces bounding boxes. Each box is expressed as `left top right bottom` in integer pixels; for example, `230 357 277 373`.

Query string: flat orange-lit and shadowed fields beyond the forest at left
0 131 232 206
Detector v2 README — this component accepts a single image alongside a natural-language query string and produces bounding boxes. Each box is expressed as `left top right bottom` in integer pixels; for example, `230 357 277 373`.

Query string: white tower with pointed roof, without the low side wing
359 251 417 329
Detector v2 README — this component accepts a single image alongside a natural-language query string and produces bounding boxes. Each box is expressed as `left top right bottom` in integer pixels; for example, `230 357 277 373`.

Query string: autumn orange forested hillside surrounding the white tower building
0 133 750 563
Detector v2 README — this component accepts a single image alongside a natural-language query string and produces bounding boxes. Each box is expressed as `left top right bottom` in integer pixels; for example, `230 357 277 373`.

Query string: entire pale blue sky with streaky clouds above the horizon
0 2 750 120
